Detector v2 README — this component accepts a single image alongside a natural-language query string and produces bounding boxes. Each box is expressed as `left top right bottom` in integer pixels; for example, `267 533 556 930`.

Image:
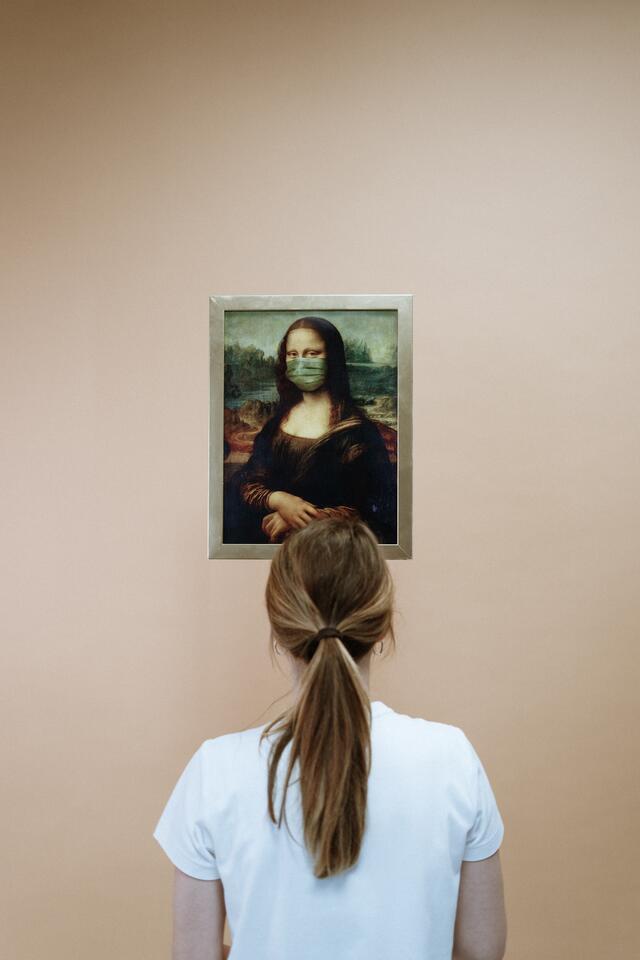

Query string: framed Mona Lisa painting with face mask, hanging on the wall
209 294 413 559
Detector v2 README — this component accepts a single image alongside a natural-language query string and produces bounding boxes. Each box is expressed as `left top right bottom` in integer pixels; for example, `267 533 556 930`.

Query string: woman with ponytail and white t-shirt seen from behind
154 518 506 960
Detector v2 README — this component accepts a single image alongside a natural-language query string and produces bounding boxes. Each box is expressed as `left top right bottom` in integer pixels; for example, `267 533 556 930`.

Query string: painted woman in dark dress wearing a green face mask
223 316 397 543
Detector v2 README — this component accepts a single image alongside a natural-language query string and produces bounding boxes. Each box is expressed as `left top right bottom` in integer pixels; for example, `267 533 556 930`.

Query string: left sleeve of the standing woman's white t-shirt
153 741 220 880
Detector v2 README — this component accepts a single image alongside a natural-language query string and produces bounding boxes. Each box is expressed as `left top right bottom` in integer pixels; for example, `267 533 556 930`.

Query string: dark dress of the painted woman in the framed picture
223 415 397 543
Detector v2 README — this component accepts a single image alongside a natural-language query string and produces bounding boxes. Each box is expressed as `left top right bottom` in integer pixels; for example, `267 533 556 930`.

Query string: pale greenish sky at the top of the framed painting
224 310 398 363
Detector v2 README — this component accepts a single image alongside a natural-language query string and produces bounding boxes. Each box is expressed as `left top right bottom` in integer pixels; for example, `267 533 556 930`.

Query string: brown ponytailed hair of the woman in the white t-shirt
260 517 395 878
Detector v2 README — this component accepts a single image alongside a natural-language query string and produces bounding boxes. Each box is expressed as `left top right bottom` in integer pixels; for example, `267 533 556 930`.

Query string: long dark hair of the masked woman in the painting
275 316 366 425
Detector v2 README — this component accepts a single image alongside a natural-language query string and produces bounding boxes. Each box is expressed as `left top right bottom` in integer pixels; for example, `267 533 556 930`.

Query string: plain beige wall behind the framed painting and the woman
0 0 640 960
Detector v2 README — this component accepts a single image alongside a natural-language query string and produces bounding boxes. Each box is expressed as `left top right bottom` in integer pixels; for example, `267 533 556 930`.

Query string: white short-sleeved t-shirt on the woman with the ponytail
153 700 504 960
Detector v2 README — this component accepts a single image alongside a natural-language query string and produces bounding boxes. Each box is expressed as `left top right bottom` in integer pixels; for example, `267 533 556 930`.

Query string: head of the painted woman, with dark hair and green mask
276 316 354 420
